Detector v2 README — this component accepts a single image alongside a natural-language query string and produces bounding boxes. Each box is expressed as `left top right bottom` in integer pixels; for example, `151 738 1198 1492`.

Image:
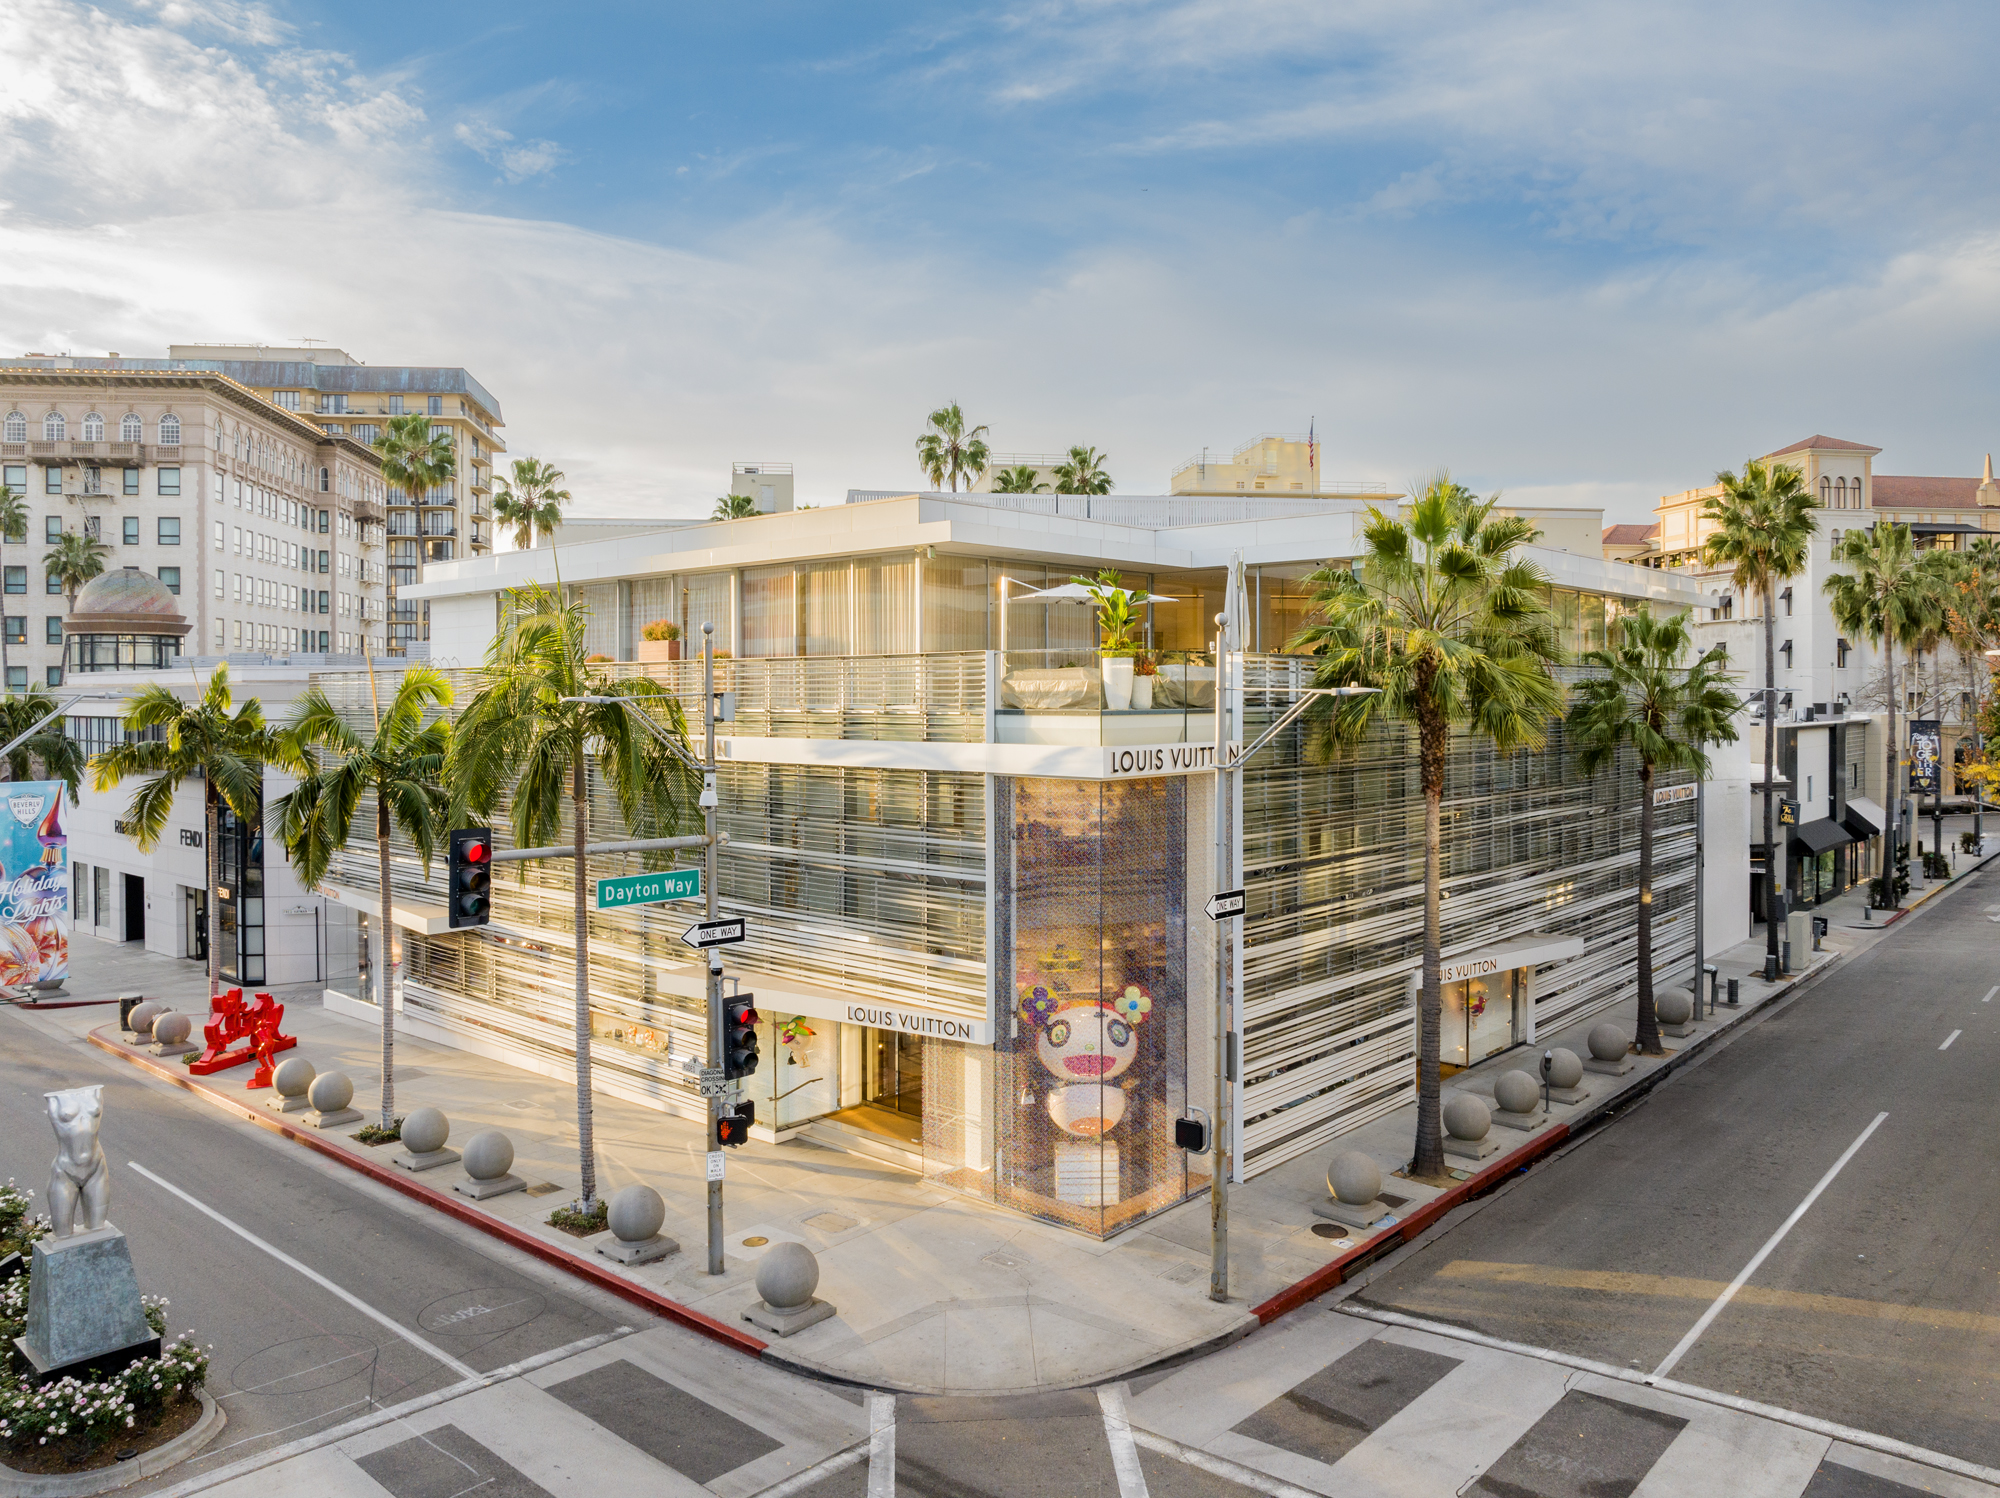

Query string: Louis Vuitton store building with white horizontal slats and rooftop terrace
326 496 1728 1236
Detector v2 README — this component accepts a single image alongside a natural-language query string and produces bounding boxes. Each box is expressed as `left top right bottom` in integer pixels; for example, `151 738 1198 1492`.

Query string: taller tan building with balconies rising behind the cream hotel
167 344 506 648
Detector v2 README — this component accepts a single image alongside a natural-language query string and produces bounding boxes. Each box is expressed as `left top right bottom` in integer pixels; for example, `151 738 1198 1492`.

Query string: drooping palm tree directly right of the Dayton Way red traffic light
444 584 698 1212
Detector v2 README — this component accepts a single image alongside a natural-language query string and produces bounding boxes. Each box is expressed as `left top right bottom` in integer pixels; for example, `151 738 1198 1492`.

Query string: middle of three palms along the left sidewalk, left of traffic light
272 666 452 1130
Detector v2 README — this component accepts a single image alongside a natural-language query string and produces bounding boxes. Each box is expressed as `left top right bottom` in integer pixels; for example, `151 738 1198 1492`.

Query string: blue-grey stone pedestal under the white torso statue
14 1222 160 1384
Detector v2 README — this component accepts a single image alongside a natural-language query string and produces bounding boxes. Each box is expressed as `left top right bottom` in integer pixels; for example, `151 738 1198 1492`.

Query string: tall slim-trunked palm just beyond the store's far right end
1702 458 1820 966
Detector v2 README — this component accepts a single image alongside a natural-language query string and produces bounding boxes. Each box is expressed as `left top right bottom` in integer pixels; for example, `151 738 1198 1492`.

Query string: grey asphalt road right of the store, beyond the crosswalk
1356 874 2000 1466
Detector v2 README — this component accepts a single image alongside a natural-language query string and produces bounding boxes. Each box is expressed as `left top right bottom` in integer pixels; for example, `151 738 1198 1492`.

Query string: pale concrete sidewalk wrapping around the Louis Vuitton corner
36 838 2000 1394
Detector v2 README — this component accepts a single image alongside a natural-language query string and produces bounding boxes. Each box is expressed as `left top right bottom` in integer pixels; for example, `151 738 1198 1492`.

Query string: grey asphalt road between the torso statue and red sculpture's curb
0 1010 630 1476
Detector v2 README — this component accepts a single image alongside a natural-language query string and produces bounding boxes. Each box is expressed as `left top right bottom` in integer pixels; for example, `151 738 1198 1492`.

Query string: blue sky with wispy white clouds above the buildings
0 0 2000 518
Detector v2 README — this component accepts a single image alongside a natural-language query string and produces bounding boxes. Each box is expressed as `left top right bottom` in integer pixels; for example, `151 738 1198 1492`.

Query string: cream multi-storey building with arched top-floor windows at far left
0 356 386 676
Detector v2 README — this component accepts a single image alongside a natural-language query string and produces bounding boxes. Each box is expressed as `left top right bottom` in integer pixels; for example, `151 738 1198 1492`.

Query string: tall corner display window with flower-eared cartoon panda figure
926 778 1206 1236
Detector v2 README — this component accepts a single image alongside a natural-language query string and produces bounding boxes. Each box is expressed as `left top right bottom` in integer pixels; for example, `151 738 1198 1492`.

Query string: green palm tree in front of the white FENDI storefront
90 666 302 1000
